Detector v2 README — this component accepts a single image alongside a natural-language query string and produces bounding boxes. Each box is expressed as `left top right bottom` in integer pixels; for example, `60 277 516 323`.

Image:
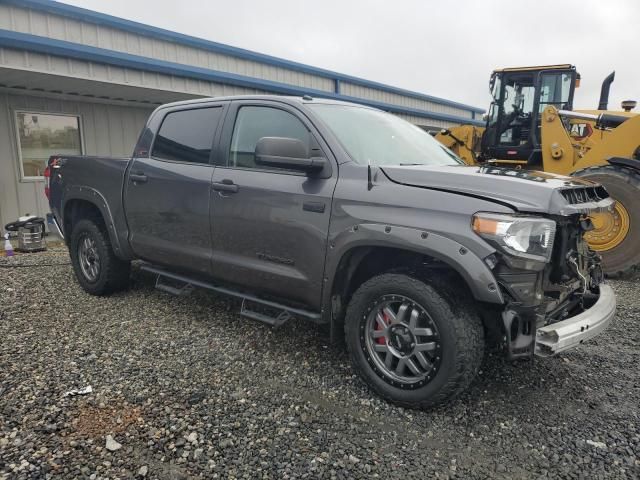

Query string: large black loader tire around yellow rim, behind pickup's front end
573 165 640 278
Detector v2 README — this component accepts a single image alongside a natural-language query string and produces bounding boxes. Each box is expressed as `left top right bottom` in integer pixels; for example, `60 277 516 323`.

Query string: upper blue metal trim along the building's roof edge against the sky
0 0 484 113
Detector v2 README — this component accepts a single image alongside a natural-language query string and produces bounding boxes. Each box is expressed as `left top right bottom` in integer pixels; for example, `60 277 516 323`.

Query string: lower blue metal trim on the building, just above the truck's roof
0 29 480 125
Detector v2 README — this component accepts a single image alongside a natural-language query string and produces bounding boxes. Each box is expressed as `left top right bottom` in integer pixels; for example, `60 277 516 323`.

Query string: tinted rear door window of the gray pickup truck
151 107 222 163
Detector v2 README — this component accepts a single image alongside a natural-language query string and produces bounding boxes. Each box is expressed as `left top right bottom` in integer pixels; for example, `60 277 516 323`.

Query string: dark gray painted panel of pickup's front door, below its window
211 168 336 308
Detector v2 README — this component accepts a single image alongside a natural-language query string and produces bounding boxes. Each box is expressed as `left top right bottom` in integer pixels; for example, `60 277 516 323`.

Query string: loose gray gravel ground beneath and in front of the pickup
0 249 640 479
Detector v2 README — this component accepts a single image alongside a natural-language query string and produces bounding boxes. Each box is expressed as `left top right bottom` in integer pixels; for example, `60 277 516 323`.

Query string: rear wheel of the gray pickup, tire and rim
69 219 131 295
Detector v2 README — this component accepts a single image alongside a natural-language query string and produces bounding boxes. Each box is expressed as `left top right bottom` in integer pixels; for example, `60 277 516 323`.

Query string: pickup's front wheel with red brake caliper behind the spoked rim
345 273 485 408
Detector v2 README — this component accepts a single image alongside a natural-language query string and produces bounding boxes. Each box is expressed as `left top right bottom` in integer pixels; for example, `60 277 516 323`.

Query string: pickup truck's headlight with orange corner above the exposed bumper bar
472 212 556 262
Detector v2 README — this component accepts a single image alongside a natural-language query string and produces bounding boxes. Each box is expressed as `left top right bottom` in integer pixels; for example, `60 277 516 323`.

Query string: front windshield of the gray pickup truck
308 103 462 165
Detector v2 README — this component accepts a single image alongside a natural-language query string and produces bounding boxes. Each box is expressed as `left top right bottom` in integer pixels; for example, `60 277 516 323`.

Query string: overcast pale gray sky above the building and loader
65 0 640 109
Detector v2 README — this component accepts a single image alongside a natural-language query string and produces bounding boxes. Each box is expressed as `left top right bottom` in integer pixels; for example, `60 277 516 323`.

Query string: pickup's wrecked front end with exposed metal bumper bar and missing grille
480 188 616 359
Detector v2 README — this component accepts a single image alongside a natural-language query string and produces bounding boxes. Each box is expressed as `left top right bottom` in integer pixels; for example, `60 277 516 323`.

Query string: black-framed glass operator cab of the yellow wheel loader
482 65 579 167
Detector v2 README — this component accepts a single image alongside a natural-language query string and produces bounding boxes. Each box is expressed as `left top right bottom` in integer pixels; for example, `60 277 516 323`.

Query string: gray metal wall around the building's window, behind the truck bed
0 91 152 231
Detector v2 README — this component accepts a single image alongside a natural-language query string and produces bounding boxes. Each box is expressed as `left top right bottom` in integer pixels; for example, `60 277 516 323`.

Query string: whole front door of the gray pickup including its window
211 101 338 308
